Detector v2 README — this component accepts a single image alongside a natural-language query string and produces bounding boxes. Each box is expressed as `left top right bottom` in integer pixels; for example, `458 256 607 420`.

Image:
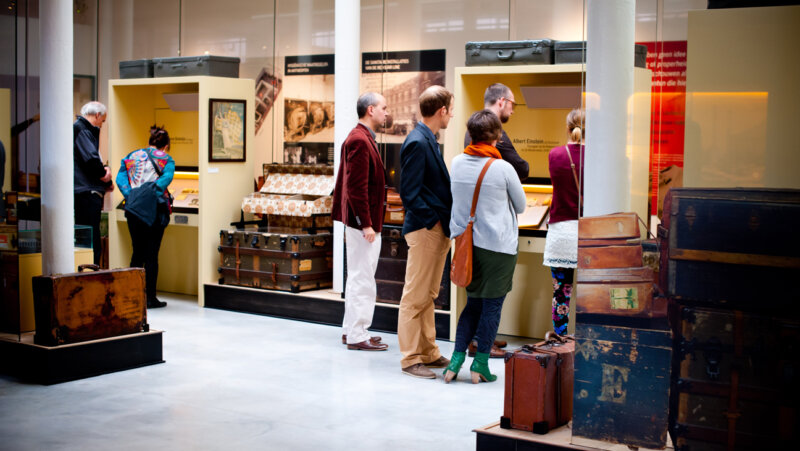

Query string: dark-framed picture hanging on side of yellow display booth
208 99 247 162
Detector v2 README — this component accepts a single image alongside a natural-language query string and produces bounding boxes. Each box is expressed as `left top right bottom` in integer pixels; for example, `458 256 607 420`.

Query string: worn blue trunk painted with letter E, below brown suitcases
572 322 672 449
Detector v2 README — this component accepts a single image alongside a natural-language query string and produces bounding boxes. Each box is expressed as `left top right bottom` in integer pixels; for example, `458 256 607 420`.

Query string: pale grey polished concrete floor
0 294 526 451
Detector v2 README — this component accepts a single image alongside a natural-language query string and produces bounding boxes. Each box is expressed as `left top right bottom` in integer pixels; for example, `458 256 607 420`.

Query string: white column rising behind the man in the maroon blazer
333 0 361 292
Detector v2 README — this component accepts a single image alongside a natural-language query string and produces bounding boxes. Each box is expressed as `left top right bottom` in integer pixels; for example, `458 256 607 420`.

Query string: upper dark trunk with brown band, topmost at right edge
658 188 800 310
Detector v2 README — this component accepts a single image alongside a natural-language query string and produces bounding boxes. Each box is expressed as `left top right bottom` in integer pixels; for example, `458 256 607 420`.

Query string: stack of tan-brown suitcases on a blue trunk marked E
572 213 672 449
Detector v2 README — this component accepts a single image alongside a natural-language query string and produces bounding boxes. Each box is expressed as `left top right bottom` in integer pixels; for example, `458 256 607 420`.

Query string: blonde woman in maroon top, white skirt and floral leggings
544 109 584 335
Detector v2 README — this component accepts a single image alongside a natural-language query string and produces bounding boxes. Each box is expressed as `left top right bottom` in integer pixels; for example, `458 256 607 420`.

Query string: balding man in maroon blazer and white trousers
332 92 389 351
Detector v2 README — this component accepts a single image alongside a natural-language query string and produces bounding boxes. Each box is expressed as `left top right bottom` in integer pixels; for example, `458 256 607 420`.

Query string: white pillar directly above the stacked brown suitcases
583 0 636 216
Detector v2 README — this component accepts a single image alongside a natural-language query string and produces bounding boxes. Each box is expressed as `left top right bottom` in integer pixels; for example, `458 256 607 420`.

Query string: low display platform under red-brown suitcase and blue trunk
473 421 673 451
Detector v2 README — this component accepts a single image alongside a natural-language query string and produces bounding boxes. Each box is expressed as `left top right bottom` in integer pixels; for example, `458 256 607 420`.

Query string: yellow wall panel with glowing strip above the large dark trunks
683 6 800 188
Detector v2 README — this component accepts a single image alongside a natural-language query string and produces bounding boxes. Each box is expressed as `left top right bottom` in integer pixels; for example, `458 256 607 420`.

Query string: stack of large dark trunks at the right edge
659 188 800 451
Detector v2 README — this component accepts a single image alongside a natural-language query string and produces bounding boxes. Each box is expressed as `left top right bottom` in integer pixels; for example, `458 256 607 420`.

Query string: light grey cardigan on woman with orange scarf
450 154 525 255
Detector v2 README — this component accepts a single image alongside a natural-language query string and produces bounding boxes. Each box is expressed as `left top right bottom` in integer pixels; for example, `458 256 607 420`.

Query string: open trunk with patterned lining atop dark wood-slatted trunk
218 164 335 293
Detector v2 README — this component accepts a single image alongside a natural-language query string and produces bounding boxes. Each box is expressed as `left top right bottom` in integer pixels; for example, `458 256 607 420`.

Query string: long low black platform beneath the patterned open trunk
203 284 450 340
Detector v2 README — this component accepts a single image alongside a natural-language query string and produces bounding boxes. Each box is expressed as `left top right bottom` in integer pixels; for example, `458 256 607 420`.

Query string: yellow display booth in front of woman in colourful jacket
109 77 256 305
